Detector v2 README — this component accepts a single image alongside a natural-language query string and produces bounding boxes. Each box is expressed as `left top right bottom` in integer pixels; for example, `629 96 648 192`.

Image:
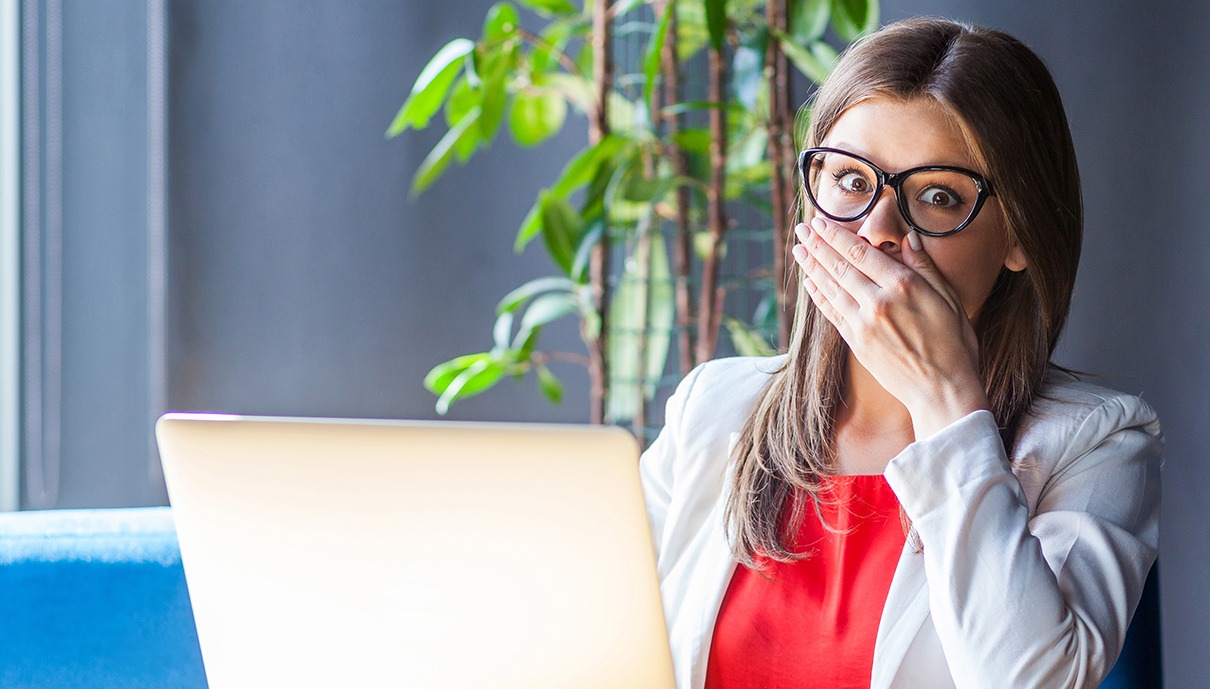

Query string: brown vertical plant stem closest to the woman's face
765 0 797 350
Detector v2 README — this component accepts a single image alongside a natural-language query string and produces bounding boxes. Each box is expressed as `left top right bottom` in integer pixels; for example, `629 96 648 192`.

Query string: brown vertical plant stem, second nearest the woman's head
697 41 727 362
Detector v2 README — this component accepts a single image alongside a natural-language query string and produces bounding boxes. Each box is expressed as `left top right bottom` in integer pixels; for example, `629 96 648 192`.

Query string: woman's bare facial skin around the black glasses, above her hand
819 98 1025 321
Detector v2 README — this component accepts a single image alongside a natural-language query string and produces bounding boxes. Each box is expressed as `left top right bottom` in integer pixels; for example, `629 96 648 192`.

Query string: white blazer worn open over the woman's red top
641 357 1163 689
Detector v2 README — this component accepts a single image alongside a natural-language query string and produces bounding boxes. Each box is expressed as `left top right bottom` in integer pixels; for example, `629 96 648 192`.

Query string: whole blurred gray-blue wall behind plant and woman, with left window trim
0 0 1210 687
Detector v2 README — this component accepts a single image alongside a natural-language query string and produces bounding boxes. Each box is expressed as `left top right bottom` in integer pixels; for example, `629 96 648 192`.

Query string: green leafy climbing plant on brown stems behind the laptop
387 0 878 430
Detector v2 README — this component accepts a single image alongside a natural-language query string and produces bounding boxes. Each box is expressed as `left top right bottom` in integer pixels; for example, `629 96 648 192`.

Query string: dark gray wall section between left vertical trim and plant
169 0 587 420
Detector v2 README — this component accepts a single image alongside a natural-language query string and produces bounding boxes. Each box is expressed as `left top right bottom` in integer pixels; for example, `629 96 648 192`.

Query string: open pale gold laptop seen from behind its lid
156 414 674 689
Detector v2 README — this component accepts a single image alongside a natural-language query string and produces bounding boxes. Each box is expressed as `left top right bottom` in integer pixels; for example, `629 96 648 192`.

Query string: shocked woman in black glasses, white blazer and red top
641 19 1160 689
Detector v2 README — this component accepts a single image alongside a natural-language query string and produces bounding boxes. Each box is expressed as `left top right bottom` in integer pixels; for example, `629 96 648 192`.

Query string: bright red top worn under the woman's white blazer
705 475 905 689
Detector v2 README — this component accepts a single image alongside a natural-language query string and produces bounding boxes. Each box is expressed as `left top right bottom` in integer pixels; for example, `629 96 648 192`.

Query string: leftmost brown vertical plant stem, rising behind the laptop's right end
583 0 613 424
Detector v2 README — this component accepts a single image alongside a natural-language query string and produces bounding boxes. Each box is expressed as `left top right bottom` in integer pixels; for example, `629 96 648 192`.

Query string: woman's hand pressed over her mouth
793 217 987 438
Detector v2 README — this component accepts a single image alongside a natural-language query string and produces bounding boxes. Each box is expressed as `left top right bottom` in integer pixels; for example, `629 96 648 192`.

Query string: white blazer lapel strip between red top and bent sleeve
870 542 928 689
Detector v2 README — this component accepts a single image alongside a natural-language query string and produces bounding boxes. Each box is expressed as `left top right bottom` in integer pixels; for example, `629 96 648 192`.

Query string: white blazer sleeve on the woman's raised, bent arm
886 395 1162 688
